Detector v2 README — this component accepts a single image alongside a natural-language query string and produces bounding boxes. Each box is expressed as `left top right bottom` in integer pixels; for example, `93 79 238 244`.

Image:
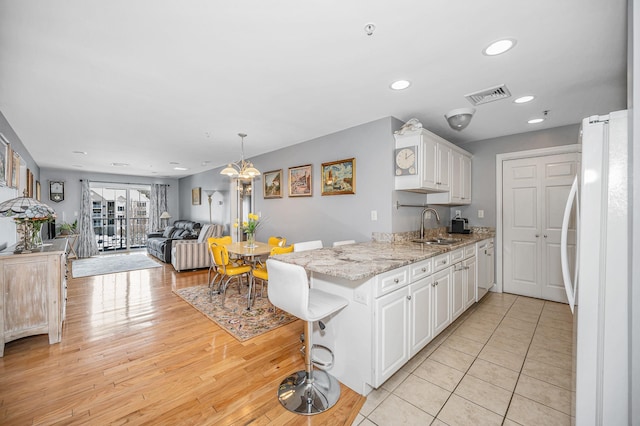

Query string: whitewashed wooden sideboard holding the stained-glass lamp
0 240 67 357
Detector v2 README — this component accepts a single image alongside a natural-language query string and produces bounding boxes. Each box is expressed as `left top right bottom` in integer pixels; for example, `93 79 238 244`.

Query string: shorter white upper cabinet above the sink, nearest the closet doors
427 148 471 205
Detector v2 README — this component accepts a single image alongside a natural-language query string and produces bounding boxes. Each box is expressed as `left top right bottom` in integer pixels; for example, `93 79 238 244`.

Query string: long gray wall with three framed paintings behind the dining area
180 117 448 246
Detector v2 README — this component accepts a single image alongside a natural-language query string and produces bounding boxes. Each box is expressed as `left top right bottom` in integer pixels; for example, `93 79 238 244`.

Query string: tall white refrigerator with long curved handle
561 111 630 426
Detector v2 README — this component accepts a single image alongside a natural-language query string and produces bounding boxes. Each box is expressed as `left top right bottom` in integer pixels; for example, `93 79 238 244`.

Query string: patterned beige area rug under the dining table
175 284 296 342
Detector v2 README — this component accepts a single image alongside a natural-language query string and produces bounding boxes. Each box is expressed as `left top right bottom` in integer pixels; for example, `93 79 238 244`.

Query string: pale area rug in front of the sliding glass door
71 254 162 278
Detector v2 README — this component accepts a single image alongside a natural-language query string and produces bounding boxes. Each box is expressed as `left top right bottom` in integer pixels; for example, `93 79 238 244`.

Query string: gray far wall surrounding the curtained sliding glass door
40 167 179 231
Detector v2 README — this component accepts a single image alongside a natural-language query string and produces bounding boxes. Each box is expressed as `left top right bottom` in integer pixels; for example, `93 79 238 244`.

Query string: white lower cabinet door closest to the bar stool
374 286 409 388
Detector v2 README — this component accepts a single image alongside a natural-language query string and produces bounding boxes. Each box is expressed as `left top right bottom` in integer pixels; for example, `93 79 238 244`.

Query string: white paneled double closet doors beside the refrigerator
502 153 580 303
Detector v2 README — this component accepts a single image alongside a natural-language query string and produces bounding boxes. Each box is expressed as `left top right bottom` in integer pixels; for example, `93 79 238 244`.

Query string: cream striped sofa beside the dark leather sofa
171 224 224 272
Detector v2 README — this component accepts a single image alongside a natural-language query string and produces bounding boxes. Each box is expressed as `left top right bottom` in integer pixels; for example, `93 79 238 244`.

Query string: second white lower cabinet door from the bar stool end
409 277 433 357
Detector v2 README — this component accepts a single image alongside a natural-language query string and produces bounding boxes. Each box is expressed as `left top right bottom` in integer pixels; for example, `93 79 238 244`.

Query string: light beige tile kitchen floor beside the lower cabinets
353 293 575 426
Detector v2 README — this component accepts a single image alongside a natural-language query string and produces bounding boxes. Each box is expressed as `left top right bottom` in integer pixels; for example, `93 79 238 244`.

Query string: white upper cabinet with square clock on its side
395 129 460 193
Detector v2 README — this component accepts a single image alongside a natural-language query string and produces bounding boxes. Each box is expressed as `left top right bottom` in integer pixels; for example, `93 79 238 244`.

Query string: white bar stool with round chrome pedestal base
267 259 349 415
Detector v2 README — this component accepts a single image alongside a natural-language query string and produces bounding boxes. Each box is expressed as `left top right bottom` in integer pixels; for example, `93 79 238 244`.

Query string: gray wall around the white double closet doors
451 124 580 227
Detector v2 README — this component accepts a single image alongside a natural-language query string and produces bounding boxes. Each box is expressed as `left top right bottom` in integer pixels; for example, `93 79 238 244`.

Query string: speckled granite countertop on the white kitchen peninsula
274 233 494 281
